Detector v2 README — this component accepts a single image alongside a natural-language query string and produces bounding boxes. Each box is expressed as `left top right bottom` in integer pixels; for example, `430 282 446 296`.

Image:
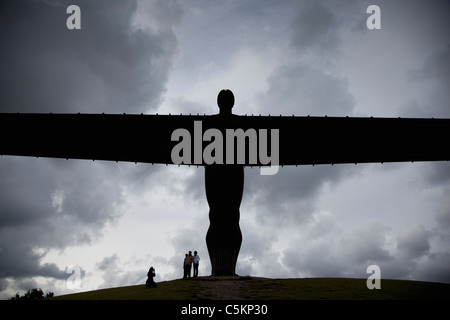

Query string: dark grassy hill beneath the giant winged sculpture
53 277 450 300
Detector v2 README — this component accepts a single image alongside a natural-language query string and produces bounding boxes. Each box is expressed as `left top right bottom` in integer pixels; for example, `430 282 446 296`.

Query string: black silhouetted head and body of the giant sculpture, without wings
205 90 244 275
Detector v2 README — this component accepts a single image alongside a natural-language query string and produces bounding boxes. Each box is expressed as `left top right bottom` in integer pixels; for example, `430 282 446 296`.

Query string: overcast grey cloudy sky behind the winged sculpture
0 0 450 299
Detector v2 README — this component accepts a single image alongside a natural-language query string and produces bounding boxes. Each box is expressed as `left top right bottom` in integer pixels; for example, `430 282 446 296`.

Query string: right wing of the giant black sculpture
237 117 450 165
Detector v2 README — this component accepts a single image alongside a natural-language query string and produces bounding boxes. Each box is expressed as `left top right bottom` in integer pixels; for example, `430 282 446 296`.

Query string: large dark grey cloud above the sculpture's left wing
0 1 176 113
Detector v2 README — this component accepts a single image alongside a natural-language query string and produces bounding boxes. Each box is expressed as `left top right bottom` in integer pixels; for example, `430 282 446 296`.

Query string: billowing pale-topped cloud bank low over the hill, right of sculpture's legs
281 214 450 282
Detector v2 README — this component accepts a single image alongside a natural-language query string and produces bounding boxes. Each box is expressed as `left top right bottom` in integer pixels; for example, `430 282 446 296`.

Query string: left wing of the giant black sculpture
0 114 192 164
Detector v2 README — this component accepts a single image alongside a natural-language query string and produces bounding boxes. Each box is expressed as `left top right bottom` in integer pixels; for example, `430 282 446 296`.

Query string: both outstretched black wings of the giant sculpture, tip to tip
0 113 450 165
